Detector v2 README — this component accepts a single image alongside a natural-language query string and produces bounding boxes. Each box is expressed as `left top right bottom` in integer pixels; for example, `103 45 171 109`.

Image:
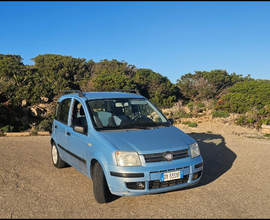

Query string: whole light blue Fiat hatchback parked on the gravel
51 90 203 203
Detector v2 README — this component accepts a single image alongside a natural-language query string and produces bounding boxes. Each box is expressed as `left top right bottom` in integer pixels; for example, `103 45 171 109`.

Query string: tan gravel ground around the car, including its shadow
0 133 270 219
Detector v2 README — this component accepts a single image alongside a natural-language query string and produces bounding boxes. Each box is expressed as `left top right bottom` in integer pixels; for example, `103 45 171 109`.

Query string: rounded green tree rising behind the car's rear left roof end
32 54 89 100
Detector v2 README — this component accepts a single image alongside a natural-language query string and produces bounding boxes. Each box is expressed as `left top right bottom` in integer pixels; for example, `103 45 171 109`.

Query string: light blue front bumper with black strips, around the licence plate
105 156 203 196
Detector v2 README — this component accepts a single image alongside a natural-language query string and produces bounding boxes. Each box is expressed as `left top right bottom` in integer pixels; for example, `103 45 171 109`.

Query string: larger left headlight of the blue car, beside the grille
115 151 141 167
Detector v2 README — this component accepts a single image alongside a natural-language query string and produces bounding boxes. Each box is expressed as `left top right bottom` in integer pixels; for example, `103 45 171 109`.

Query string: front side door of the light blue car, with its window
66 99 88 173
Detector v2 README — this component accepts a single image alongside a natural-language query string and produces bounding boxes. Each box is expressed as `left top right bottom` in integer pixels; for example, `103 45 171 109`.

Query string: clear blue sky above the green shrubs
0 1 270 83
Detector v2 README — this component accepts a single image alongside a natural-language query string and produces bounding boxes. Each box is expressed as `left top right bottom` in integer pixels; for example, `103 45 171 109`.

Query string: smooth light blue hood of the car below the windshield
100 126 195 154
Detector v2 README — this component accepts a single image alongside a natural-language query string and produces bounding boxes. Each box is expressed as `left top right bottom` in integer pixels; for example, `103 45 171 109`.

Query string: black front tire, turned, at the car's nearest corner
93 162 112 203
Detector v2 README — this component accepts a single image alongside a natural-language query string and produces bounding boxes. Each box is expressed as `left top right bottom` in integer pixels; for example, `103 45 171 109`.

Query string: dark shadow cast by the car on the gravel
188 133 237 187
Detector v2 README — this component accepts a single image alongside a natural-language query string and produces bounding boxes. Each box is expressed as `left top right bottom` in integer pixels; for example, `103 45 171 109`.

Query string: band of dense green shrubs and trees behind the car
0 54 270 132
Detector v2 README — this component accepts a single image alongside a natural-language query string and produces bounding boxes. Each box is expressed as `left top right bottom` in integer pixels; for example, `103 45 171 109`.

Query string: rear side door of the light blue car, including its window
53 98 71 159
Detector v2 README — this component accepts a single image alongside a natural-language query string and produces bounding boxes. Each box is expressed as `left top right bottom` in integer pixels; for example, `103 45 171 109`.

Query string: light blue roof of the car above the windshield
58 92 145 101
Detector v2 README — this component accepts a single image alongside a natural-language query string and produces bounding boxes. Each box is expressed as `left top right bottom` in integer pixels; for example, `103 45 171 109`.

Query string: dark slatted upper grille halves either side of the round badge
143 149 189 163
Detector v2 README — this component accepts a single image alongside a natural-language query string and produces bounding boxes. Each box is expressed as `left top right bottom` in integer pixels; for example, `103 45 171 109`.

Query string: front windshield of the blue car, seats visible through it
87 98 171 130
